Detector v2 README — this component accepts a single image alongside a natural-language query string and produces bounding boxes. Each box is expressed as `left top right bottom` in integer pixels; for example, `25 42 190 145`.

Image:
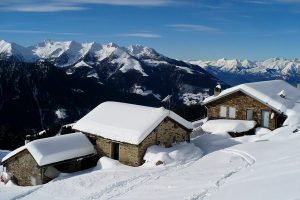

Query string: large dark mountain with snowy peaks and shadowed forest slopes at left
0 40 226 149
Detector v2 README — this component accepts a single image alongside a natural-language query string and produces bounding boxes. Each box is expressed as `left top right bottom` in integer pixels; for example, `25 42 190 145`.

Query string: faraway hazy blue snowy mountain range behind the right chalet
189 58 300 85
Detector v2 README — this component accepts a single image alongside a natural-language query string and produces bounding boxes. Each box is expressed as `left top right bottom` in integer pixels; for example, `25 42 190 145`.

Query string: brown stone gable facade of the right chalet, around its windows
206 91 279 130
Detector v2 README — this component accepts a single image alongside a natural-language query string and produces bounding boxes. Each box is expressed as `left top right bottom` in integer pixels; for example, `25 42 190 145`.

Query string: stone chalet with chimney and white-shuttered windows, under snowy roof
203 80 300 130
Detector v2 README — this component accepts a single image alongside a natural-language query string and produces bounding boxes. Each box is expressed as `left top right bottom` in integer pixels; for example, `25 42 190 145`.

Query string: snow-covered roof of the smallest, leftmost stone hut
2 133 96 166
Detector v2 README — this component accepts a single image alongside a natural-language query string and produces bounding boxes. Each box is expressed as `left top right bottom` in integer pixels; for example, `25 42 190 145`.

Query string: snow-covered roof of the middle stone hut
73 102 193 144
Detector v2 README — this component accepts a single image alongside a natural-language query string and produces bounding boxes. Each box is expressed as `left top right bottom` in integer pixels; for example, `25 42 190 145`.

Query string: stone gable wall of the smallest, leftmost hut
4 149 43 186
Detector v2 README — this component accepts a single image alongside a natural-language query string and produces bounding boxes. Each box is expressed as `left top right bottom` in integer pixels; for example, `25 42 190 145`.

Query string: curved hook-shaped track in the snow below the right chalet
185 149 256 200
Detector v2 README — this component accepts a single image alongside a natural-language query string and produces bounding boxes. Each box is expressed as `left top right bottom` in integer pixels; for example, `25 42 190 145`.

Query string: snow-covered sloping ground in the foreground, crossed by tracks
0 122 300 200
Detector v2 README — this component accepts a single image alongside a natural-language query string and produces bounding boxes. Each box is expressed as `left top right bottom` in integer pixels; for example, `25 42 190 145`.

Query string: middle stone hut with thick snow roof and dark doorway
73 102 192 166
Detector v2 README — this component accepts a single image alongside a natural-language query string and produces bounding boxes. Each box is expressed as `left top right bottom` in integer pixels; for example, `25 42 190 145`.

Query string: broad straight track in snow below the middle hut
84 158 198 200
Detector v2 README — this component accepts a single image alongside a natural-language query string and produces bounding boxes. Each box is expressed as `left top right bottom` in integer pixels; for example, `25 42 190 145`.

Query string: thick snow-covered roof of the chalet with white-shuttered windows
203 80 300 114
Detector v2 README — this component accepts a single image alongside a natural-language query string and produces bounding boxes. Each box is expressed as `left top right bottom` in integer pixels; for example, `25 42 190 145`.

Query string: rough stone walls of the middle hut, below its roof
92 118 190 166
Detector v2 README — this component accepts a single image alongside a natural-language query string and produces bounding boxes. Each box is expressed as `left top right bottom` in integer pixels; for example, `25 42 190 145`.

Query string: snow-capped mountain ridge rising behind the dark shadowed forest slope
0 40 223 105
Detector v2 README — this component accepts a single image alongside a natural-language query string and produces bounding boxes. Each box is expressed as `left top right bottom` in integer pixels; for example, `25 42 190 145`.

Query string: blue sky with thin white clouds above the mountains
0 0 300 60
